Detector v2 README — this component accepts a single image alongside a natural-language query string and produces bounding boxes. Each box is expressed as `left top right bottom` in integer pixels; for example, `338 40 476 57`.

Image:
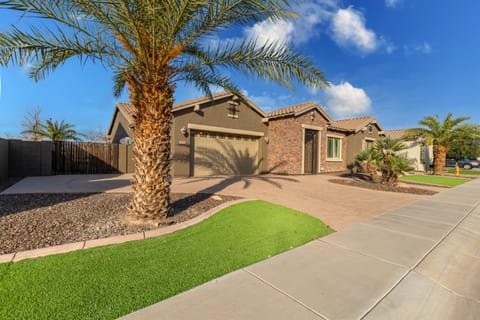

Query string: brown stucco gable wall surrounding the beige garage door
172 97 268 176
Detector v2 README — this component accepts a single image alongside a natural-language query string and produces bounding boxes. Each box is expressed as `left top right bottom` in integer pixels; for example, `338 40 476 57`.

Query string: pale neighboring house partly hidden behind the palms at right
385 129 433 171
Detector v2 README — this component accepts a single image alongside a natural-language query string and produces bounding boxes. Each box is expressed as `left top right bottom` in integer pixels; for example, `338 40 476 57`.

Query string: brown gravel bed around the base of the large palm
0 193 239 254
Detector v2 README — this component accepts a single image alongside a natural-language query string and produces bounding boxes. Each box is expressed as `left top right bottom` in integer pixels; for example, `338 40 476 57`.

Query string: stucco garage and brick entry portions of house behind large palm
108 92 349 176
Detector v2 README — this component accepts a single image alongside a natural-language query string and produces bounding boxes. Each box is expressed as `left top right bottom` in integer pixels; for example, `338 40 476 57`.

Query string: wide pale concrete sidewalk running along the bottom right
122 179 480 320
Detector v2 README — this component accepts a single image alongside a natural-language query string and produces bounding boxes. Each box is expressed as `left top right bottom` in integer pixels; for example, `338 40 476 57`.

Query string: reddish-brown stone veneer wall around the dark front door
268 111 327 174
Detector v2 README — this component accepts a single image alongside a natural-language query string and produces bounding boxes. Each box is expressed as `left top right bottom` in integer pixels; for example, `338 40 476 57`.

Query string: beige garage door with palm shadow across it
192 131 258 176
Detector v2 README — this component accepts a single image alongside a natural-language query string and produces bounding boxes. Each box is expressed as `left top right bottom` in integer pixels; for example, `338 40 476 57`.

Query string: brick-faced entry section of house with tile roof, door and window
267 102 347 174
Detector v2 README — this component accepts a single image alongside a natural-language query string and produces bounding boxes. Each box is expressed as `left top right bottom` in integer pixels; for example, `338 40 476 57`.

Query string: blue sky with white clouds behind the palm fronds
0 0 480 136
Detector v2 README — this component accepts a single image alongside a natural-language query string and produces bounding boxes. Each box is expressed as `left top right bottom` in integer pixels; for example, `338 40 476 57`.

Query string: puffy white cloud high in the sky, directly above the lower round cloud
332 7 379 54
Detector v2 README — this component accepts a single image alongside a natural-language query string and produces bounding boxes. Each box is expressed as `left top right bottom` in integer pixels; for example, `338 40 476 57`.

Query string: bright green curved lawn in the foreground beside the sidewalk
0 201 332 319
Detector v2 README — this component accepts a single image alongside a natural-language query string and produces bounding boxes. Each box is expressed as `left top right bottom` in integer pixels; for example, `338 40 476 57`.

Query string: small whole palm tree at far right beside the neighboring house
406 112 470 175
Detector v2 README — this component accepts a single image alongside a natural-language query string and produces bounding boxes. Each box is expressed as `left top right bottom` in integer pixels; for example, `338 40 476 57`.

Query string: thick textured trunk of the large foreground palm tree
129 82 173 223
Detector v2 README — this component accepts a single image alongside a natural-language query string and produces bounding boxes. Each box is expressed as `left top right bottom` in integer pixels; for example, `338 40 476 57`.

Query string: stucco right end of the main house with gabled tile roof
330 116 385 167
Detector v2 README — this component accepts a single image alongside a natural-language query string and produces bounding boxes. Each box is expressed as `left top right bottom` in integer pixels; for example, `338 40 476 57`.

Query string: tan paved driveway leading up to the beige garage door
3 175 436 230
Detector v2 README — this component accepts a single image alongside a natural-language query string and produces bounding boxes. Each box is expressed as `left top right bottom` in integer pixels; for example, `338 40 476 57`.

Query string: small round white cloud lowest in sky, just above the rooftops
325 82 372 116
